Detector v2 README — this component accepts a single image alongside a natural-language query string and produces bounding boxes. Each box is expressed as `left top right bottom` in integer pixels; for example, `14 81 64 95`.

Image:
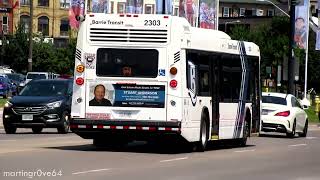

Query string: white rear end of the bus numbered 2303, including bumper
70 14 182 143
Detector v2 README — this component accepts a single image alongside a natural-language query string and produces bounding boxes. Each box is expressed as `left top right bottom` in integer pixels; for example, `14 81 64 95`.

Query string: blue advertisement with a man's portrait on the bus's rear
89 83 165 108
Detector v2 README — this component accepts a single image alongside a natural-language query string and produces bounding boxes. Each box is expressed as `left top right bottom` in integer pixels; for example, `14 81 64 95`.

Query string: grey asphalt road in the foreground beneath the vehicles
0 125 320 180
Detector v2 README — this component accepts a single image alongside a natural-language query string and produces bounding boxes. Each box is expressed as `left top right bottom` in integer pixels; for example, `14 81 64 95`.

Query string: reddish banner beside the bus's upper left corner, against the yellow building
69 0 85 29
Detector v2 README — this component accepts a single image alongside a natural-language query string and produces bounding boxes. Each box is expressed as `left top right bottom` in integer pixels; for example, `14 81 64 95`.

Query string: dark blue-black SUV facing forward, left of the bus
3 79 73 134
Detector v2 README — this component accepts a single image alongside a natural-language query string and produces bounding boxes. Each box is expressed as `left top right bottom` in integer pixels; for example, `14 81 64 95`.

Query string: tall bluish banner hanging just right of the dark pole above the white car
294 0 309 49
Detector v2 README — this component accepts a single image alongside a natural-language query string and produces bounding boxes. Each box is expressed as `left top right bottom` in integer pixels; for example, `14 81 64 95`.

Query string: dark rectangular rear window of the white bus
96 48 159 78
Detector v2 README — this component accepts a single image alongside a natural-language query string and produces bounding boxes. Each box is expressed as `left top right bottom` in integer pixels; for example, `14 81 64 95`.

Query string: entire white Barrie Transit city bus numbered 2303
70 14 261 150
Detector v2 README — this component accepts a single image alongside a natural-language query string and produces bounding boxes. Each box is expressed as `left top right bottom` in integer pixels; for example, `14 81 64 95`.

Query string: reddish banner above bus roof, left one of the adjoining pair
179 0 199 27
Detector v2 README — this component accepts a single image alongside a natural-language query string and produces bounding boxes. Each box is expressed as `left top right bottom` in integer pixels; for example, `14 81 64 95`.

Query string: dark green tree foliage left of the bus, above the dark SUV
2 25 76 74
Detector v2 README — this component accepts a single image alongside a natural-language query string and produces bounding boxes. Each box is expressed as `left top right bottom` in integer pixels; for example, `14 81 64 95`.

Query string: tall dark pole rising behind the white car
288 0 297 95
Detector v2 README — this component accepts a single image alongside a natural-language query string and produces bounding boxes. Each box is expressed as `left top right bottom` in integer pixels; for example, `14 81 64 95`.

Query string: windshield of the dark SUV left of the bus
20 81 68 96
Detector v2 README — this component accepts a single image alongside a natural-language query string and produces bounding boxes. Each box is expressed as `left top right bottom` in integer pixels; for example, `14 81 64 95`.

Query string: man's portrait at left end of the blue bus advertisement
89 84 114 106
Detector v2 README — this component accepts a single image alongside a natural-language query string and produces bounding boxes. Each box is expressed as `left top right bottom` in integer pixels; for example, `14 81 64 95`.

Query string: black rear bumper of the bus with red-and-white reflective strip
70 119 181 140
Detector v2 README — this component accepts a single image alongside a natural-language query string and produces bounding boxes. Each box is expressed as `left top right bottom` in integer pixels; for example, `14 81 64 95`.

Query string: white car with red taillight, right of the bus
261 92 308 138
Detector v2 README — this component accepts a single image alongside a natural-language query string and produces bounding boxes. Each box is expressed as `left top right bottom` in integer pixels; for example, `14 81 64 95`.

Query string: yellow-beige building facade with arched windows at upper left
13 0 70 45
